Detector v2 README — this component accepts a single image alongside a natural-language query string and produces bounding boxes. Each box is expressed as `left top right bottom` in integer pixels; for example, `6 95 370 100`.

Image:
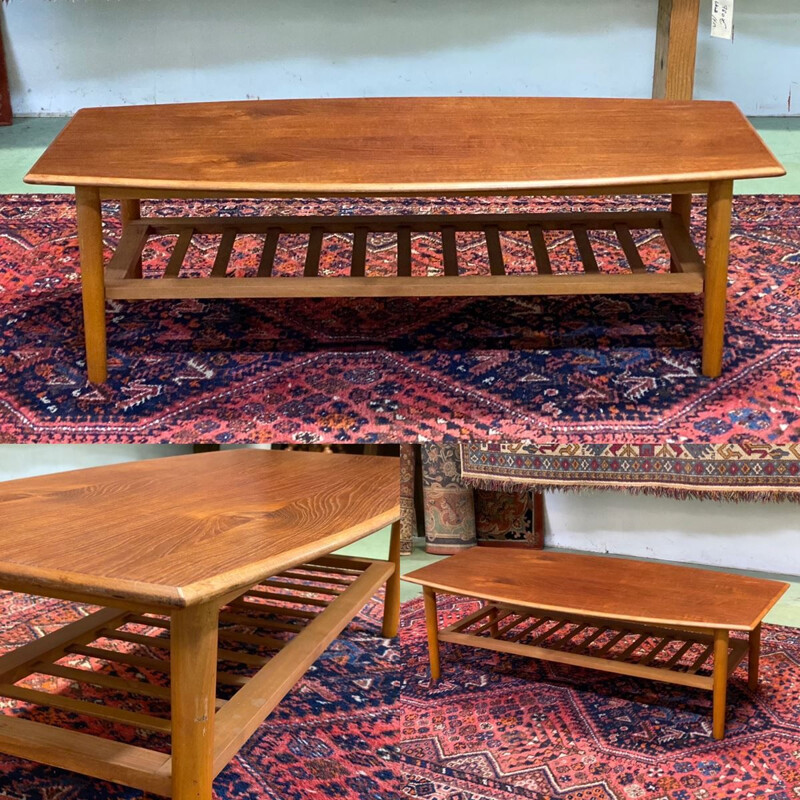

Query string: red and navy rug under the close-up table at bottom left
0 592 402 800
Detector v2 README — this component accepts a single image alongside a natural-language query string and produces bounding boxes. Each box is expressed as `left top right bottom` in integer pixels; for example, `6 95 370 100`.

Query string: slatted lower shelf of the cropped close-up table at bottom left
0 556 394 796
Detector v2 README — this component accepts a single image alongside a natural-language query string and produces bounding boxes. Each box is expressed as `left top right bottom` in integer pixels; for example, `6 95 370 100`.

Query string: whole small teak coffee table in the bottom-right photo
404 547 788 739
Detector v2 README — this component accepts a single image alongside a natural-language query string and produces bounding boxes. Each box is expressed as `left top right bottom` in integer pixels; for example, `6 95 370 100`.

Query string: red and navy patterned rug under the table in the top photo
0 196 800 444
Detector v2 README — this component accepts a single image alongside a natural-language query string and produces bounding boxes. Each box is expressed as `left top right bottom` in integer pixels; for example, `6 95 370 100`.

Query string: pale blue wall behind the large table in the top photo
4 0 800 115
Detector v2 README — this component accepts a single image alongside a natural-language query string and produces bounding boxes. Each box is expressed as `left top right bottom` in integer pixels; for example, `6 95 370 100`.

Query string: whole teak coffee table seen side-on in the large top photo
26 97 784 382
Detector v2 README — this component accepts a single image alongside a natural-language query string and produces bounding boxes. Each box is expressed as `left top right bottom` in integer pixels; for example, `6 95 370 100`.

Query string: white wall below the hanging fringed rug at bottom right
545 491 800 575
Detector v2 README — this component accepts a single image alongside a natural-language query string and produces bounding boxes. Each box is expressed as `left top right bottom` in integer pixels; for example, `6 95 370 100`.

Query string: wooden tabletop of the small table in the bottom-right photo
403 547 789 630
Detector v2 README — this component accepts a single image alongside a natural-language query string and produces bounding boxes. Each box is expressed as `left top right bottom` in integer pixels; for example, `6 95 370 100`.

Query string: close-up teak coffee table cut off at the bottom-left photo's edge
0 450 400 800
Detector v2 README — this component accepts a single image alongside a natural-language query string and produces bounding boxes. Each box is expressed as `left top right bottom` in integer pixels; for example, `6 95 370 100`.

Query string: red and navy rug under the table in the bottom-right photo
400 598 800 800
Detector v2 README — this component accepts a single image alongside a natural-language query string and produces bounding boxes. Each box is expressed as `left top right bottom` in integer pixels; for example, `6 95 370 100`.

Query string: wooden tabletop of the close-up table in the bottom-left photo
0 450 400 606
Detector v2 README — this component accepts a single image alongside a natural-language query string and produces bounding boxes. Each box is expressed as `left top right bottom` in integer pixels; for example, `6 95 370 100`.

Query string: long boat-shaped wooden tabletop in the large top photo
25 97 784 196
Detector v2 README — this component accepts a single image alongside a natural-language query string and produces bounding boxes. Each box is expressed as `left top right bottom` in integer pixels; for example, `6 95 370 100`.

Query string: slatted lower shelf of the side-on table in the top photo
106 211 704 299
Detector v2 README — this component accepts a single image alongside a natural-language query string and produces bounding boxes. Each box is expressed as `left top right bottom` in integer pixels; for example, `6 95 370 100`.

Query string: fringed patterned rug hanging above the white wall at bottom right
456 441 800 501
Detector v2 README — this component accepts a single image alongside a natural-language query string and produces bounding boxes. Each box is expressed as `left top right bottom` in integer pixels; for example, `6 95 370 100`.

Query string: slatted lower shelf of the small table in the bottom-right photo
439 603 748 690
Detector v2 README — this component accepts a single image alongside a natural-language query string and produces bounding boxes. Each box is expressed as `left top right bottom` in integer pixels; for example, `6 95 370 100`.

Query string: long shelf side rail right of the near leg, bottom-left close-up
214 562 394 774
